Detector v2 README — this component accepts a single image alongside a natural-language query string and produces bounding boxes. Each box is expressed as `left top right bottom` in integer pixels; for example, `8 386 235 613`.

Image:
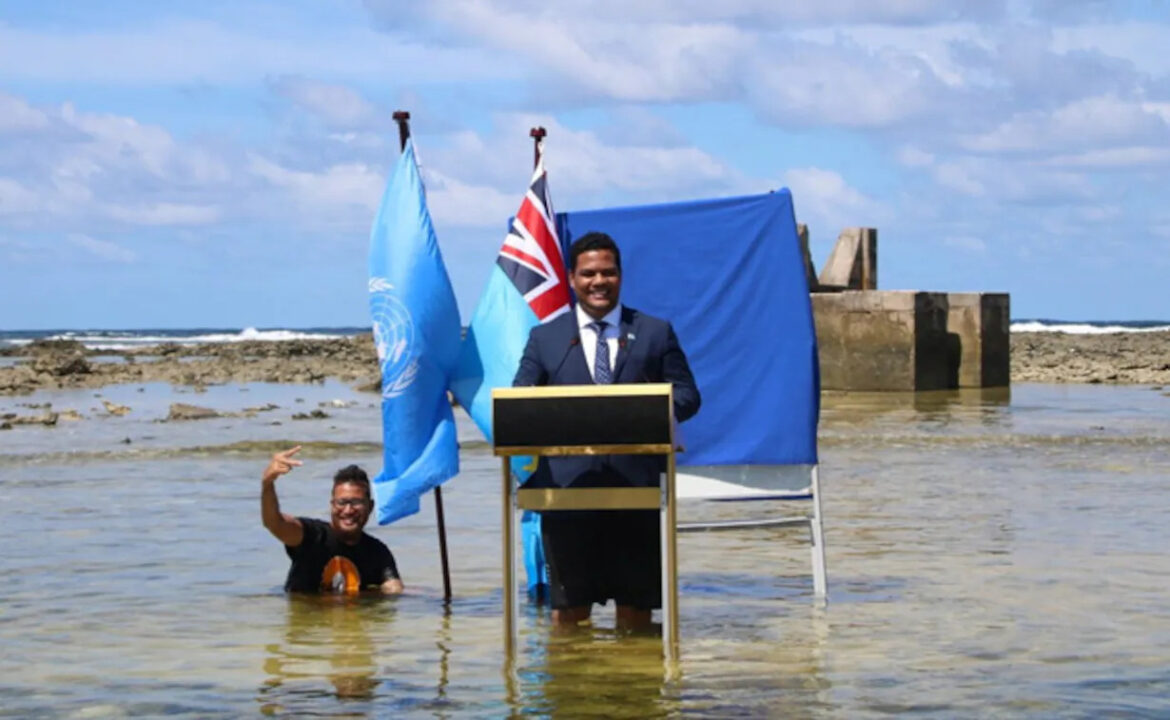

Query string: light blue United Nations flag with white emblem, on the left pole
370 140 460 524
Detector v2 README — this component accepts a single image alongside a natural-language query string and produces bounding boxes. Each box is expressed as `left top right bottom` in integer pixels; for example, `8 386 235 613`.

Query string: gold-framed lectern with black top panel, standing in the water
491 383 679 661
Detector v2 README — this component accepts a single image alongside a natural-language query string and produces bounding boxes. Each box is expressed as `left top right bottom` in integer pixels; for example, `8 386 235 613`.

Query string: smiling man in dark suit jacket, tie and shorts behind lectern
512 233 700 629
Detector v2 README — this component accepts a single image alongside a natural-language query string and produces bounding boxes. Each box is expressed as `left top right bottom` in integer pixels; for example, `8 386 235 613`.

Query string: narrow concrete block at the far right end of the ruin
947 293 1011 388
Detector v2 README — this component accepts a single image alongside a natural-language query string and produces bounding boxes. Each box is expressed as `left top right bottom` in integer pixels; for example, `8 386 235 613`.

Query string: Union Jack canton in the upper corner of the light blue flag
496 148 569 323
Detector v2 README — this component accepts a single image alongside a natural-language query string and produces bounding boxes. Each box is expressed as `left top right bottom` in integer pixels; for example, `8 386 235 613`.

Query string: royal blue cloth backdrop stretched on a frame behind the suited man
558 190 820 465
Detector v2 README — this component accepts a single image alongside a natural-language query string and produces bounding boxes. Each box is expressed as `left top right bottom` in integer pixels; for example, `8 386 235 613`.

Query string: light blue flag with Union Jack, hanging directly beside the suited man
450 143 570 594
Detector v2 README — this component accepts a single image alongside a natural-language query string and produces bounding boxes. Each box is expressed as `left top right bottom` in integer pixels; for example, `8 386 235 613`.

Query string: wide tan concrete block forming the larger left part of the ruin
812 290 955 391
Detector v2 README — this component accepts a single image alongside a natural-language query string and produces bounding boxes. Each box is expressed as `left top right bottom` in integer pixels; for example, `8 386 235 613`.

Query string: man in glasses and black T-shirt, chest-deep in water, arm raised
260 445 402 595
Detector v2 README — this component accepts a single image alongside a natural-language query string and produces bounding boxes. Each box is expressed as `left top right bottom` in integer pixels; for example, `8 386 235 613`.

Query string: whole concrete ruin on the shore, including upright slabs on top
797 225 1011 391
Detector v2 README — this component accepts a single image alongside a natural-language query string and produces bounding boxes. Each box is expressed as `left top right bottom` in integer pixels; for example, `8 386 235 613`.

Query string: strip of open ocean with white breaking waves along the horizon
0 317 1170 351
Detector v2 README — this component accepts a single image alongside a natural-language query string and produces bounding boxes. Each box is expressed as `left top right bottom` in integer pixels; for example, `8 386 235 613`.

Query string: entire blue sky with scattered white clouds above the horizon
0 0 1170 329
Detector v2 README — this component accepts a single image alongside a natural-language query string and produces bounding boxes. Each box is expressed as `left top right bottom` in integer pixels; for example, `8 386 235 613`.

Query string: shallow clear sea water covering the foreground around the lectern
0 383 1170 718
